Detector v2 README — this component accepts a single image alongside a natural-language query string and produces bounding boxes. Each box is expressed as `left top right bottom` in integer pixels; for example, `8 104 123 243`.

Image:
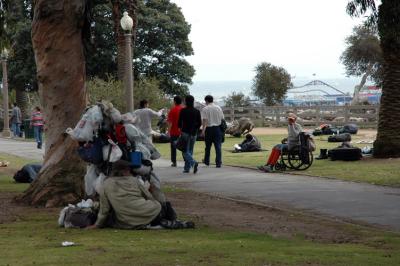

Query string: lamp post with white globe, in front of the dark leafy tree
121 12 133 112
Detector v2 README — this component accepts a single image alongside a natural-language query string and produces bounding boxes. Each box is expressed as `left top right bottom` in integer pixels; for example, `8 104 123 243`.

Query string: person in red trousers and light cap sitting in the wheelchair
258 113 303 172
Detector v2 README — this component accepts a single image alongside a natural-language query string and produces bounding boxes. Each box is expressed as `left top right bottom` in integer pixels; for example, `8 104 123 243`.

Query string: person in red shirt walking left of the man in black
168 96 183 167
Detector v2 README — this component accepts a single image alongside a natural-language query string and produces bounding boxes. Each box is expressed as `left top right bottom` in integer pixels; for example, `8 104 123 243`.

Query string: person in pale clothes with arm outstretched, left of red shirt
133 100 163 142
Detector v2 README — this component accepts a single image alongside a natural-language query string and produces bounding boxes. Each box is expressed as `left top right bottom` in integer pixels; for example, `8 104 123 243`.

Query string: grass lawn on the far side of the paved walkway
156 135 400 187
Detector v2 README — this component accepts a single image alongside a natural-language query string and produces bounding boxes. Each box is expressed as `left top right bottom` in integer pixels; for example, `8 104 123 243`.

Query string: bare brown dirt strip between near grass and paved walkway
167 187 360 243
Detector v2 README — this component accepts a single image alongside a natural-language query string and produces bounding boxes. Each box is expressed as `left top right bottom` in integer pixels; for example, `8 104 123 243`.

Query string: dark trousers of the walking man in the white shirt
204 126 222 166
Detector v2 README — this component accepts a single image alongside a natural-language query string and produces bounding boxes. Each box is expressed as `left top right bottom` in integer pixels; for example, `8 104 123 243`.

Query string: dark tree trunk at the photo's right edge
374 0 400 158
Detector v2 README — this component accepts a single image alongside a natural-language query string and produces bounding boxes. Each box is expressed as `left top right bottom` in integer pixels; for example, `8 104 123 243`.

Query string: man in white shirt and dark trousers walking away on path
201 95 224 168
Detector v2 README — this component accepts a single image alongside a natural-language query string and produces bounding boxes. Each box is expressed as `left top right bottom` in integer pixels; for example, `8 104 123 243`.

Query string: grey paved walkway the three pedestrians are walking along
0 139 400 231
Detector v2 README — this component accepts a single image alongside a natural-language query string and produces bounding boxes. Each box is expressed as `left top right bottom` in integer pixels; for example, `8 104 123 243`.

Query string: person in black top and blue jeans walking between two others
178 95 201 173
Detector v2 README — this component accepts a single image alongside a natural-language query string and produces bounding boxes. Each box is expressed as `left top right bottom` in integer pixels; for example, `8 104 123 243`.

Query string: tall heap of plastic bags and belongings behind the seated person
66 102 161 196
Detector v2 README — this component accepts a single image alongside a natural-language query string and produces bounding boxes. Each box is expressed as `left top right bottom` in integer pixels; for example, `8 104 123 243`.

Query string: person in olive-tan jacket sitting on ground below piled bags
89 160 194 229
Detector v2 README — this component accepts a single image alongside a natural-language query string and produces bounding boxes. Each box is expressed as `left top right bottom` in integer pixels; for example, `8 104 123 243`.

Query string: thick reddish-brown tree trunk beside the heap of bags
19 0 86 207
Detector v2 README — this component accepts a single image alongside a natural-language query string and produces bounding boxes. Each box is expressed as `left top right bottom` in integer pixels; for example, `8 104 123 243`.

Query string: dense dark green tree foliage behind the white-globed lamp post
87 0 195 95
